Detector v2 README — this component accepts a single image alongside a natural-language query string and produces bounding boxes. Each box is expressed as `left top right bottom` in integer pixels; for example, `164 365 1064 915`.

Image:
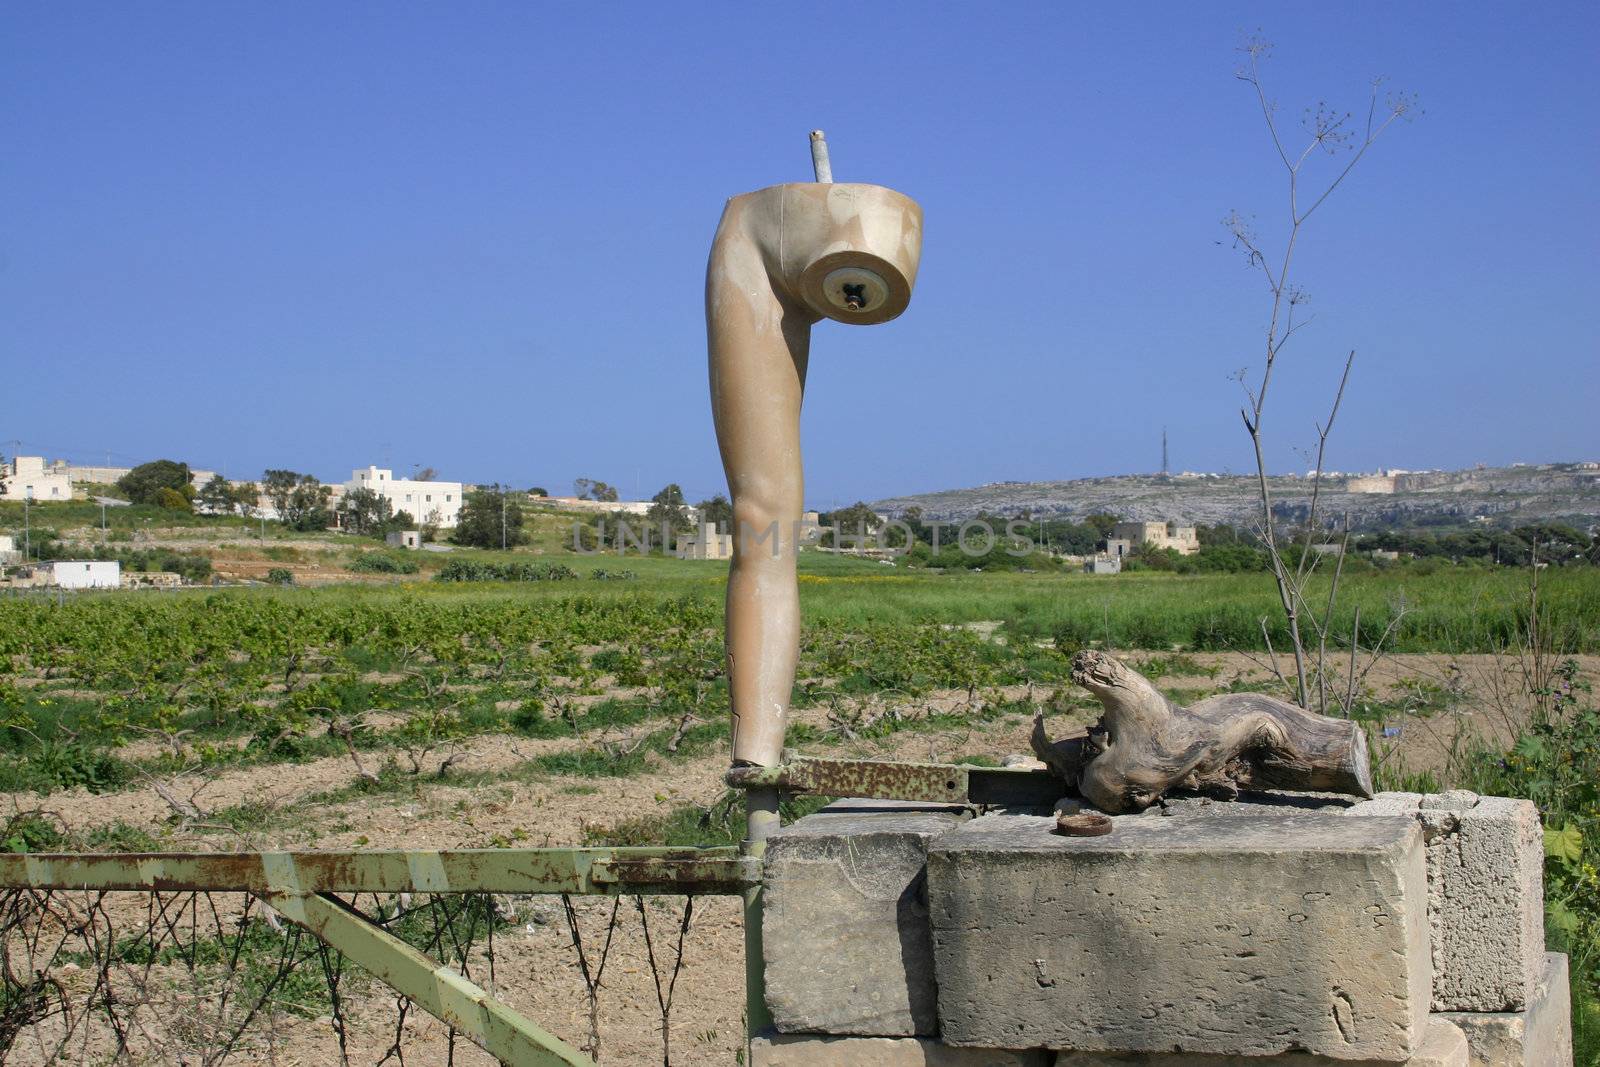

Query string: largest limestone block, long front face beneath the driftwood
928 813 1432 1062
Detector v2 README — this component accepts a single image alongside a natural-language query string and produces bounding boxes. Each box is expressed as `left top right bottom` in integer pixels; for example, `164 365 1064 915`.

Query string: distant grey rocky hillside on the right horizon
872 462 1600 528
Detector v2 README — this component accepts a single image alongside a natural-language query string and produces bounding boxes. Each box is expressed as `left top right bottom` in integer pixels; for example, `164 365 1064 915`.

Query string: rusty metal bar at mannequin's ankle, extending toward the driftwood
728 750 1072 808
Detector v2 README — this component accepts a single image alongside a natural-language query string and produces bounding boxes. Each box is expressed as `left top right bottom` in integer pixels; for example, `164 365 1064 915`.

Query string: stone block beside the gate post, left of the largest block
762 800 963 1037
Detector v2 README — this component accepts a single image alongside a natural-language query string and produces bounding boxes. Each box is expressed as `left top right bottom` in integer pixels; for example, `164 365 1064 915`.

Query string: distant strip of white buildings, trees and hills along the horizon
0 456 1600 590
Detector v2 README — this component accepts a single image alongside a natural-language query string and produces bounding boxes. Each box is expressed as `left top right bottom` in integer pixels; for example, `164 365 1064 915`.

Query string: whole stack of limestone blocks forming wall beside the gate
750 793 1571 1067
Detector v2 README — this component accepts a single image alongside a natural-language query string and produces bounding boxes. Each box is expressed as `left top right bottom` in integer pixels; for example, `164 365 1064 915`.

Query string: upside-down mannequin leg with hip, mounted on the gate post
706 182 922 766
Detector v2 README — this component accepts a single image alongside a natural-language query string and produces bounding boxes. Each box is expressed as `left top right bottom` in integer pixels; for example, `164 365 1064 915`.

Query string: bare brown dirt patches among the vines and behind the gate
9 653 1600 1067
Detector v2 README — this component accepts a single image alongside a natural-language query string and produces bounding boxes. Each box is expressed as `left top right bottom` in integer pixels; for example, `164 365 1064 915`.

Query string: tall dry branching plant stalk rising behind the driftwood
1222 38 1418 713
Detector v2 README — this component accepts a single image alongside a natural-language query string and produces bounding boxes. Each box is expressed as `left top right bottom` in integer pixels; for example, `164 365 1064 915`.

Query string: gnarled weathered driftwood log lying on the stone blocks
1032 651 1373 814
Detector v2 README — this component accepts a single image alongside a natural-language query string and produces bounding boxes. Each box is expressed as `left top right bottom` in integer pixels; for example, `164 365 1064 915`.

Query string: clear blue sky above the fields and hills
0 3 1600 507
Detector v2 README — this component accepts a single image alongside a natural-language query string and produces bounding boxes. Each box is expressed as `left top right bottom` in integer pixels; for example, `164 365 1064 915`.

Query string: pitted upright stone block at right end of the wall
1350 790 1544 1013
